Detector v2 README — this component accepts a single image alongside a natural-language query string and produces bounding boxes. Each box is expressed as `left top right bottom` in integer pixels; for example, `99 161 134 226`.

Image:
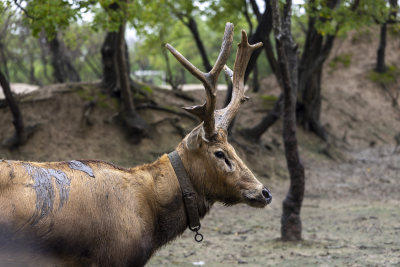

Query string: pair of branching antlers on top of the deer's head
165 23 262 138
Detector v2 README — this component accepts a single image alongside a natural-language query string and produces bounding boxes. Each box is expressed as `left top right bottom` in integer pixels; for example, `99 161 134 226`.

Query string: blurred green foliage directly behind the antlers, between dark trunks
132 0 252 83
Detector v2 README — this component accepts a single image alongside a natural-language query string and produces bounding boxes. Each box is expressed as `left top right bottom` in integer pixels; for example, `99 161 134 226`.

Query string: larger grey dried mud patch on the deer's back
24 164 71 224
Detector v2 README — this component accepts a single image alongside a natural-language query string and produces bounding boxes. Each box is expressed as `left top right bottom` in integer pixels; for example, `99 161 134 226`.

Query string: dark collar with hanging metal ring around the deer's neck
168 150 203 242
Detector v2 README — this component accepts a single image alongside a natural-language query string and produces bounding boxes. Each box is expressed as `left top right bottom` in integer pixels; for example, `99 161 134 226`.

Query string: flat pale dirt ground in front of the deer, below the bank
148 148 400 266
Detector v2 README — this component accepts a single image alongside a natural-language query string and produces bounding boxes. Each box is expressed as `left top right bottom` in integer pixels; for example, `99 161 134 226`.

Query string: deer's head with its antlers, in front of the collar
166 23 272 207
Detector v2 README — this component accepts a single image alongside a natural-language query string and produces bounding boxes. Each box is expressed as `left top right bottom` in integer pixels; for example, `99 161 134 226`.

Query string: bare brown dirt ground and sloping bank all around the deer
0 28 400 266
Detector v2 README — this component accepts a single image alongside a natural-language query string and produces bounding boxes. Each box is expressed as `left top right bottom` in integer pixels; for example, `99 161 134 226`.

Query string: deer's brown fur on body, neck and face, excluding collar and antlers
0 129 272 266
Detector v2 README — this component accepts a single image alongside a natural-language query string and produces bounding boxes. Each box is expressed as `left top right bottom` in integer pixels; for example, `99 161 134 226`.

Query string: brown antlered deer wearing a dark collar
0 23 272 266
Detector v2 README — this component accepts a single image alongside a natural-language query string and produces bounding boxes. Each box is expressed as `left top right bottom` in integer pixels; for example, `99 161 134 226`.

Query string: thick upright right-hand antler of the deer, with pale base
215 30 262 130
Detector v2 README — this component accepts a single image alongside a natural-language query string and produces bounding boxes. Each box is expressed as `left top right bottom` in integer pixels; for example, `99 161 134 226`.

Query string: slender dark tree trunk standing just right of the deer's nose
272 0 305 241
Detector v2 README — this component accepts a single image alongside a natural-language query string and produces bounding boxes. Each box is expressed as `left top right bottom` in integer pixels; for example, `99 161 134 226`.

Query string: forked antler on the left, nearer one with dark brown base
165 23 233 137
